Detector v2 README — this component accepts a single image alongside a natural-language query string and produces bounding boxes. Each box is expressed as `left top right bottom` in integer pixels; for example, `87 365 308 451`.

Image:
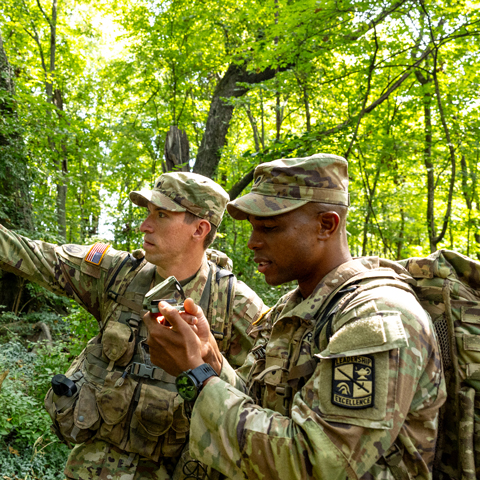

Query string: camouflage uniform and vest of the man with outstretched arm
0 226 265 480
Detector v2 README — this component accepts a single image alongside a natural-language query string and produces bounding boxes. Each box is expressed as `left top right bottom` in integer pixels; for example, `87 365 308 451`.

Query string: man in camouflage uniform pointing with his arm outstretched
0 173 265 480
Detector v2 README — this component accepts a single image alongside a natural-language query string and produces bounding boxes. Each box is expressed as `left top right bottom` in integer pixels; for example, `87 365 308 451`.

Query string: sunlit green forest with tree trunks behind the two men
0 0 480 480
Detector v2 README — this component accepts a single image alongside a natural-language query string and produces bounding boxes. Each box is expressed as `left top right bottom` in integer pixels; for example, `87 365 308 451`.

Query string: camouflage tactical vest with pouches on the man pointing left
45 250 236 461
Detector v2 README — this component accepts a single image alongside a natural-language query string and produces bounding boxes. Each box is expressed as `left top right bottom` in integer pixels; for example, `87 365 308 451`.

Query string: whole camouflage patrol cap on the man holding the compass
227 153 349 220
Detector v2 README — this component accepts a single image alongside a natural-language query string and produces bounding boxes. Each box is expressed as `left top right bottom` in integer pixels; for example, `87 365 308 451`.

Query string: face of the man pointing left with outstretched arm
140 203 195 269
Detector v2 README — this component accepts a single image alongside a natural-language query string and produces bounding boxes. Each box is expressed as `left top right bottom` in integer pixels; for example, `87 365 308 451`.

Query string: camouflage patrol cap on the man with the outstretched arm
130 172 229 227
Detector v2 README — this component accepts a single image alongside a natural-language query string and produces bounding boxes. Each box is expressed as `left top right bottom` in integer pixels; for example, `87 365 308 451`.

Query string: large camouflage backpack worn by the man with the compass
400 250 480 480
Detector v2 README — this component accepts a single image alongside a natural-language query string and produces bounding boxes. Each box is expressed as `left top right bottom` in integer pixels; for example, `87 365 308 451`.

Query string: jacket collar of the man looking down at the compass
278 257 379 323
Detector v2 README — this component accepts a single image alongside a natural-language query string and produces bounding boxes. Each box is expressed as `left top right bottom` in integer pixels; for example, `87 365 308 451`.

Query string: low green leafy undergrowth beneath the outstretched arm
0 305 97 480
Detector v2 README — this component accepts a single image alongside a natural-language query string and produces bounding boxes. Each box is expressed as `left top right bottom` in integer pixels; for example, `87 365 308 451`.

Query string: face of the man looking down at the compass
248 207 318 285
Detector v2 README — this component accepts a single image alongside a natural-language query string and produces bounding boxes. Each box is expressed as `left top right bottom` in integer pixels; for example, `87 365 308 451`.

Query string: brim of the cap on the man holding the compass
227 193 309 220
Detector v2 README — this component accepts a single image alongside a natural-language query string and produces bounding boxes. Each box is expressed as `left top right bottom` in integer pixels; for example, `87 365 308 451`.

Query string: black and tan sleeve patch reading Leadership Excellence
332 355 375 410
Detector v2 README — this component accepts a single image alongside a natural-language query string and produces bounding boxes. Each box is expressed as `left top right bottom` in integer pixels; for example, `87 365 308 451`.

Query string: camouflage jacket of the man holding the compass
190 257 446 480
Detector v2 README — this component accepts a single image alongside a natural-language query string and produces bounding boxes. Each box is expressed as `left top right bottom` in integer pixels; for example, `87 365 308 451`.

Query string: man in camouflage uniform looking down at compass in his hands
144 154 446 480
